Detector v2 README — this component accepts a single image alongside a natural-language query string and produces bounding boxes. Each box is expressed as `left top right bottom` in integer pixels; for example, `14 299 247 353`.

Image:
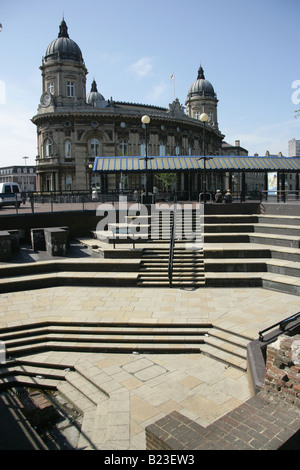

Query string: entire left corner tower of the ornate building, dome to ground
32 20 88 191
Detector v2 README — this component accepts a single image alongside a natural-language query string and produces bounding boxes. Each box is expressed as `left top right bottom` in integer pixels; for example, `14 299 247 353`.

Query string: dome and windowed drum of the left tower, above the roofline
39 20 87 112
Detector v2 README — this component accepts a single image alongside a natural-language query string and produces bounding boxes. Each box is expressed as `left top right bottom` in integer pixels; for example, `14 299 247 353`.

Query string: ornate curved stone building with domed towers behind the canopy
32 20 224 191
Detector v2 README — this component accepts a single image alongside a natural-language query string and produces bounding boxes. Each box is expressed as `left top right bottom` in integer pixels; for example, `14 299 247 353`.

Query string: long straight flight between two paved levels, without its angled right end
0 324 210 357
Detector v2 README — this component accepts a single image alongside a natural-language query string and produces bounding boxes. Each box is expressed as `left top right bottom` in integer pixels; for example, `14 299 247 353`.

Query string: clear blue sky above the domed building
0 0 300 166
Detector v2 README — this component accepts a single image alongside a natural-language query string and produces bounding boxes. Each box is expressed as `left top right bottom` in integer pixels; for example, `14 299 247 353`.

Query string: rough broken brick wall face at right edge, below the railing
263 335 300 408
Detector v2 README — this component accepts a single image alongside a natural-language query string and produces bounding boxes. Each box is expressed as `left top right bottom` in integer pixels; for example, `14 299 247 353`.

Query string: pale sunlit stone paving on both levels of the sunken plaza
0 287 299 450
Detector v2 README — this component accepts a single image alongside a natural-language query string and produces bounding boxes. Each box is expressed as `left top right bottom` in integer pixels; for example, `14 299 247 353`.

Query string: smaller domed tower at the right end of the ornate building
185 66 218 130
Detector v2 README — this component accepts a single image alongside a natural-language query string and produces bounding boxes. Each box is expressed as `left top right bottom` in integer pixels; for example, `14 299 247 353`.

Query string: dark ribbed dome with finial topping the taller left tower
44 20 83 63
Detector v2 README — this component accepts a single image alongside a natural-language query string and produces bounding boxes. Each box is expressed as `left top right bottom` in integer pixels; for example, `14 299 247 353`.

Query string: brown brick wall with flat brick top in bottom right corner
146 335 300 451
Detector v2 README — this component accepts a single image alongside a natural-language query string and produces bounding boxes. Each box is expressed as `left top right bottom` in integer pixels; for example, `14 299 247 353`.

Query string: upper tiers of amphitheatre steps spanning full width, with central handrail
0 211 300 295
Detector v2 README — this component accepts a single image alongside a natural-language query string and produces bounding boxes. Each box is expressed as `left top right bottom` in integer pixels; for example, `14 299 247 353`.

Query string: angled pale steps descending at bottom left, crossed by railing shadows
0 356 130 450
